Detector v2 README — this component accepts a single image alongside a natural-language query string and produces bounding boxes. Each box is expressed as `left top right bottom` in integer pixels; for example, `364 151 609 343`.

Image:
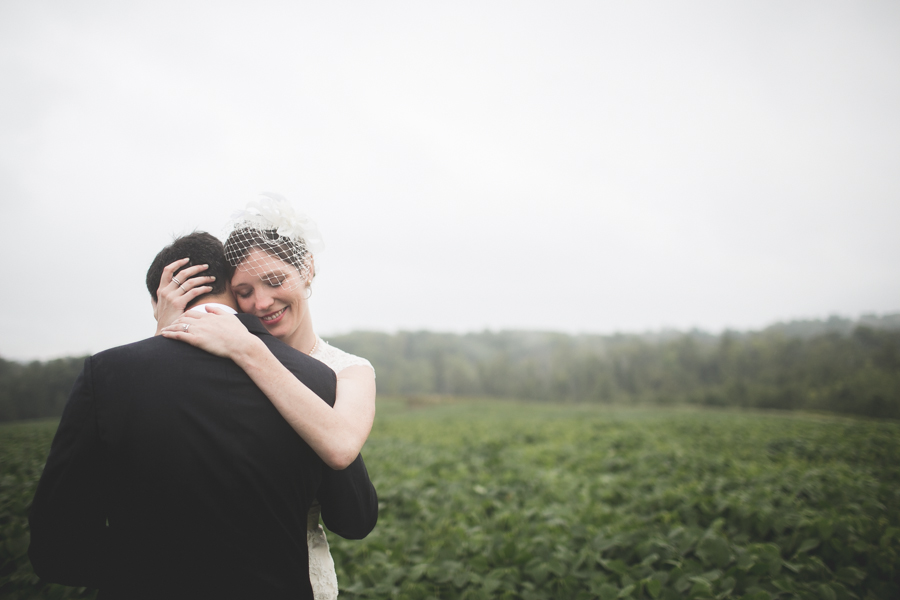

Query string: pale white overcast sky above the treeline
0 0 900 359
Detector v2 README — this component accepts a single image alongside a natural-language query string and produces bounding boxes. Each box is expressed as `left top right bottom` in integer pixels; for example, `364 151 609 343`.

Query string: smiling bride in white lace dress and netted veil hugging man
154 194 375 600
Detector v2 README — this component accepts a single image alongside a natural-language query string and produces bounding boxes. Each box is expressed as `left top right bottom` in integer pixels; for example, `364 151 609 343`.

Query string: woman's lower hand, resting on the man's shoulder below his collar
162 306 256 359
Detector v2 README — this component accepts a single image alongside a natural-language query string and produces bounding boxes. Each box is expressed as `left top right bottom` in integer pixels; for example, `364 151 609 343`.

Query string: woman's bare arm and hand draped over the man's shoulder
162 309 375 469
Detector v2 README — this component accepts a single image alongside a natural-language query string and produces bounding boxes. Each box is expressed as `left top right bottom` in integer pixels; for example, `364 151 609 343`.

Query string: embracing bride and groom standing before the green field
29 195 378 600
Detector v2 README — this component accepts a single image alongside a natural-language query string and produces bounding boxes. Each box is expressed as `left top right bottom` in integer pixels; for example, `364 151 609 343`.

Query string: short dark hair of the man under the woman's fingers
147 231 234 304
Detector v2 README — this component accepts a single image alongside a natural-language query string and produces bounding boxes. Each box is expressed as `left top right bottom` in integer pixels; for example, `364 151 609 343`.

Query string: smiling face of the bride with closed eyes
231 248 311 349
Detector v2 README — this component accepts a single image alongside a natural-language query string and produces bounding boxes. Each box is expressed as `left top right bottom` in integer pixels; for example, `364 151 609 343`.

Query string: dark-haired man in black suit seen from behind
28 233 378 600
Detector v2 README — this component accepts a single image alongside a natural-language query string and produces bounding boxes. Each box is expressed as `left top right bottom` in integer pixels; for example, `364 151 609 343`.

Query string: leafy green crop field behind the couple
0 400 900 600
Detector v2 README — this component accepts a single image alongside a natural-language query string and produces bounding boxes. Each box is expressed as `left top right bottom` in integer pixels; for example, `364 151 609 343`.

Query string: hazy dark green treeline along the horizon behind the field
0 314 900 421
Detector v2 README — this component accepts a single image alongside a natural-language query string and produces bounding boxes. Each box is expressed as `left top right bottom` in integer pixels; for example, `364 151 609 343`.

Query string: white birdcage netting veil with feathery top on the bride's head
225 193 324 291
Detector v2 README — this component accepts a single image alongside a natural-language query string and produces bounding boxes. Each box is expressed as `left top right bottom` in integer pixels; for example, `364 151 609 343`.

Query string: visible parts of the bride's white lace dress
306 338 374 600
